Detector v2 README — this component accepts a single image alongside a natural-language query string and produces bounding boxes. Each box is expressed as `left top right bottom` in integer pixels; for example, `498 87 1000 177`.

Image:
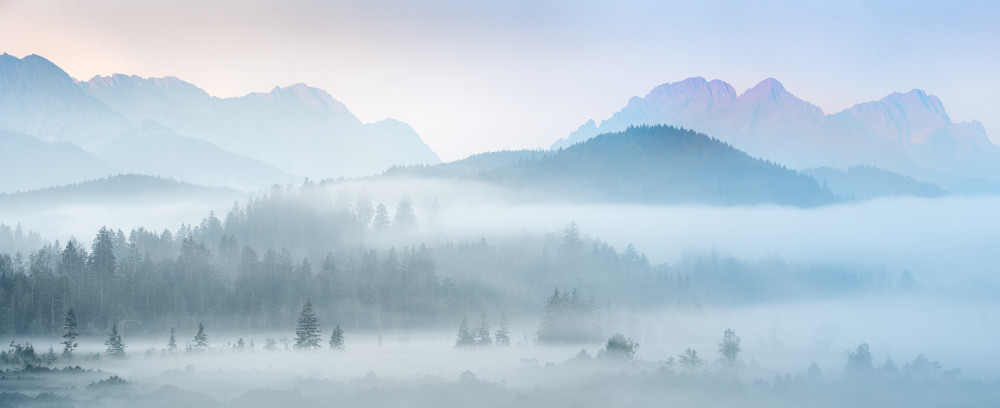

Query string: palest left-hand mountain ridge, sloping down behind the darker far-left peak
81 75 440 179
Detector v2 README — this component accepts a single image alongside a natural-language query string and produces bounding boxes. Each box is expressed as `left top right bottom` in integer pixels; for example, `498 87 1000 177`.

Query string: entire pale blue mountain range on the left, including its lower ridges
0 54 440 191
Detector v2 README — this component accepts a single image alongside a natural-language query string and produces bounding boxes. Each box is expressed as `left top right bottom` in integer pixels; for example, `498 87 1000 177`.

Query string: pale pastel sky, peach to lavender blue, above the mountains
0 0 1000 161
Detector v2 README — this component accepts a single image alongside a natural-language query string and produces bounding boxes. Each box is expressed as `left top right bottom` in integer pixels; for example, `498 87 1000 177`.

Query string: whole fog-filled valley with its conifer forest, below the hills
0 177 1000 406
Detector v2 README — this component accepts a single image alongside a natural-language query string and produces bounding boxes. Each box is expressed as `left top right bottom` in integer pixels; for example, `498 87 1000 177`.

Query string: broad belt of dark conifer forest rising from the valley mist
0 186 893 336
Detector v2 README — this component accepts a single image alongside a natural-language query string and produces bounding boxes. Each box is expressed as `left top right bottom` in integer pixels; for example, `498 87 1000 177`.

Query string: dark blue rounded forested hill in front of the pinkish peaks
479 126 838 207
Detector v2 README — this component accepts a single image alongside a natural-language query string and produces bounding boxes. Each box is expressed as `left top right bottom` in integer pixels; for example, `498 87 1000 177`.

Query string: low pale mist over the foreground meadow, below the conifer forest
0 296 1000 407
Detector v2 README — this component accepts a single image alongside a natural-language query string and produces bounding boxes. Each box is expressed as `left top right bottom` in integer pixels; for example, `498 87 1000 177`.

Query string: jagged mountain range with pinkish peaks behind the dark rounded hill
552 77 1000 187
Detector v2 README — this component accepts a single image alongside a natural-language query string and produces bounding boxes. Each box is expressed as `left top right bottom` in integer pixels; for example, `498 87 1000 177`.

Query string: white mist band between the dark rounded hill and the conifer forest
329 179 1000 286
